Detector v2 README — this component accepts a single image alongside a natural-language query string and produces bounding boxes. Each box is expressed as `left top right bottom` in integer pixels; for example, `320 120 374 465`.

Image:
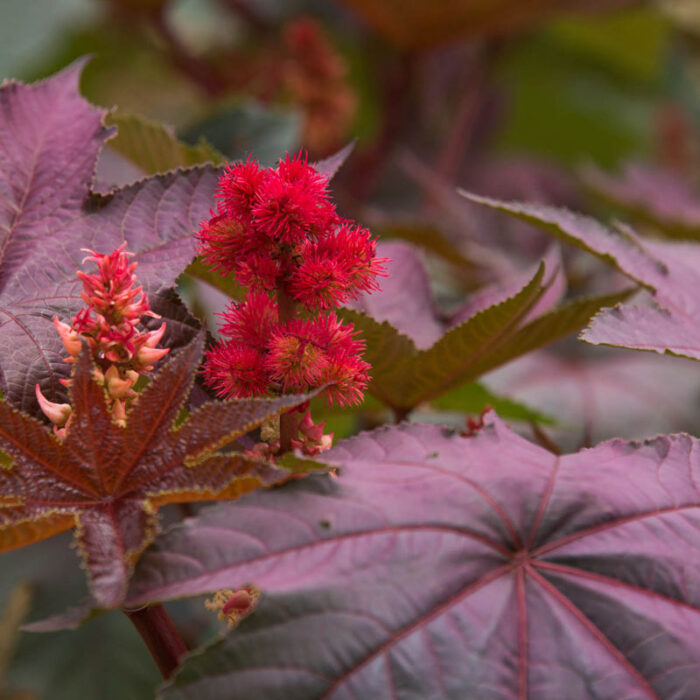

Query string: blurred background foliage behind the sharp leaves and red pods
0 0 700 700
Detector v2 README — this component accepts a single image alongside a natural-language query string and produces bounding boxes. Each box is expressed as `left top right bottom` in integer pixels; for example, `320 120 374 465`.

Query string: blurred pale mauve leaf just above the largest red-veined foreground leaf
481 346 700 449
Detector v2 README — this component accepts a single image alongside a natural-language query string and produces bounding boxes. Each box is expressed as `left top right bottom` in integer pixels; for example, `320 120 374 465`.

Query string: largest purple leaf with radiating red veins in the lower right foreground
128 414 700 700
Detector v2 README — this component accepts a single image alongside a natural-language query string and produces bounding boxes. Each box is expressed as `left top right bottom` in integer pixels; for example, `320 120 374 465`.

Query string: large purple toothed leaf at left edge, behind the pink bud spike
0 61 218 415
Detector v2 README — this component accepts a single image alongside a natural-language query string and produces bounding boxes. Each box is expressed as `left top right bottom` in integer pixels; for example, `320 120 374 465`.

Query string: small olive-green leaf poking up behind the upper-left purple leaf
106 112 226 175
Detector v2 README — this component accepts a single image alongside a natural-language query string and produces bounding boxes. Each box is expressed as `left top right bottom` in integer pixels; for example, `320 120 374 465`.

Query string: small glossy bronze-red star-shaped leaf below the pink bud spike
0 335 310 607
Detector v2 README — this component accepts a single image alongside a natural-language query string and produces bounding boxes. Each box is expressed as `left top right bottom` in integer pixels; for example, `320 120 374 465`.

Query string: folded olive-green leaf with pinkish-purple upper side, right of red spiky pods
341 243 628 413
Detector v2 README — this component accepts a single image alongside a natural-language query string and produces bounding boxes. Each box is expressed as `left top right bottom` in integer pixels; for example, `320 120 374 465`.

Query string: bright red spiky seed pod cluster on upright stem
198 154 384 422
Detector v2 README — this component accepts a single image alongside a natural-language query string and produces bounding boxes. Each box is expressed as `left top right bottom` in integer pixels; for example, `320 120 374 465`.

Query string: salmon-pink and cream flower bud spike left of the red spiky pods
36 243 169 437
